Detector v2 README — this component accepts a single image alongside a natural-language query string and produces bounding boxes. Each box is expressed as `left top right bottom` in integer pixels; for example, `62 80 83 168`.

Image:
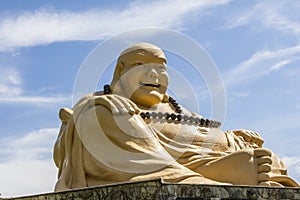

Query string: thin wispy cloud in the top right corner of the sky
227 0 300 35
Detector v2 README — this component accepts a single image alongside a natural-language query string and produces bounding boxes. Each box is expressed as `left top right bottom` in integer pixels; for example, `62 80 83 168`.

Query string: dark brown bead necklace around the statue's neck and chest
104 85 221 128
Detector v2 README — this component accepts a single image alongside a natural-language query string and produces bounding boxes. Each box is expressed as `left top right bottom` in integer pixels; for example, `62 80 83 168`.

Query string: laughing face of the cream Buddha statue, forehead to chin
119 54 169 107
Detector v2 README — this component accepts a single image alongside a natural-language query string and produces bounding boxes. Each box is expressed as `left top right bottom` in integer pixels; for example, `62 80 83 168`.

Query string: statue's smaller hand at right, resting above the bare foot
232 129 264 148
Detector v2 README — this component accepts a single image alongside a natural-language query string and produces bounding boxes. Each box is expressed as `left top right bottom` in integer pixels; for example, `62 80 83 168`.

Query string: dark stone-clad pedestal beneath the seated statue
8 180 300 200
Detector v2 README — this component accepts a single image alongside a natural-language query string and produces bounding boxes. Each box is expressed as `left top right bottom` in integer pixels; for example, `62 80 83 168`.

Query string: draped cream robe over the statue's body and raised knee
54 94 296 191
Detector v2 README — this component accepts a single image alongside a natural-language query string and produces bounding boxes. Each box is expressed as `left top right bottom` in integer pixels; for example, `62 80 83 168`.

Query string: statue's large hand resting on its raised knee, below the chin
89 94 140 115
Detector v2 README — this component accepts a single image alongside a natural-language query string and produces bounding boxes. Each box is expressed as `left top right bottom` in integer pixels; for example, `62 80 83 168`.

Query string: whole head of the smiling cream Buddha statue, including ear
111 43 169 107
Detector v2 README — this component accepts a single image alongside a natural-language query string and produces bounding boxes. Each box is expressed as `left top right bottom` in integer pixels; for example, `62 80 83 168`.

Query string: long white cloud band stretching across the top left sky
0 0 228 51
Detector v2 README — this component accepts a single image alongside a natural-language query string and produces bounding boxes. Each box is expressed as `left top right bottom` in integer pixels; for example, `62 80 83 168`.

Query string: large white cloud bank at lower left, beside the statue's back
0 128 58 197
